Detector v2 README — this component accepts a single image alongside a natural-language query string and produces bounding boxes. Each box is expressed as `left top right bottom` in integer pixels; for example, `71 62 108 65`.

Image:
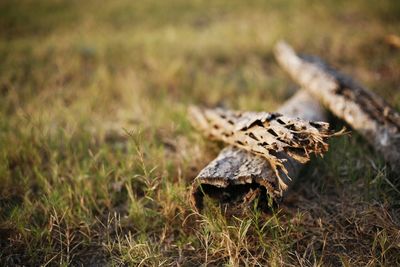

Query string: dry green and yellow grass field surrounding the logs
0 0 400 266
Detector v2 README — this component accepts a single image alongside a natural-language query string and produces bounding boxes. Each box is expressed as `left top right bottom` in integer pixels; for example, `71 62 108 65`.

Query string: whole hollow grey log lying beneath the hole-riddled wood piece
191 91 326 209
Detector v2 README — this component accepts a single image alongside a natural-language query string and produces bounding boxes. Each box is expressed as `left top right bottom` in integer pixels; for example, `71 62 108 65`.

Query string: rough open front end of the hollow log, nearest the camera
190 146 297 210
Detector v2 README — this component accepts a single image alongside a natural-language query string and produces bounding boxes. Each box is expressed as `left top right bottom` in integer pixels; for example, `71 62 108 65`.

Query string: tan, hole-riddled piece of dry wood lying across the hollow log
189 107 343 189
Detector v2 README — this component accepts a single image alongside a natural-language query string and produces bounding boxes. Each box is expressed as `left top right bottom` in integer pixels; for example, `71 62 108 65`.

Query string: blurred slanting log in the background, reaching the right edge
275 42 400 172
